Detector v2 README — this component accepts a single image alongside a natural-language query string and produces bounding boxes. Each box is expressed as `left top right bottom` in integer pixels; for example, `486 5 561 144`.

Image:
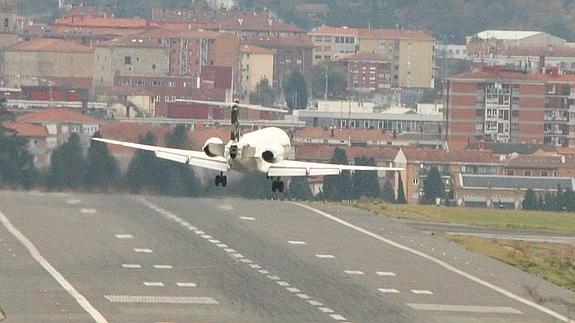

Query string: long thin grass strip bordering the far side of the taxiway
355 202 575 233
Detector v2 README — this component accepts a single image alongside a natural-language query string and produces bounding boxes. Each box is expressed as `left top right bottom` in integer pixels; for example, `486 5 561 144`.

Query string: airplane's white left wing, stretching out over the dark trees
92 138 230 172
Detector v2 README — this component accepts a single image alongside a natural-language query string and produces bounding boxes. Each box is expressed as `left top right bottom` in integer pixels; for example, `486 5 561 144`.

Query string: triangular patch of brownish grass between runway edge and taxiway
443 234 575 291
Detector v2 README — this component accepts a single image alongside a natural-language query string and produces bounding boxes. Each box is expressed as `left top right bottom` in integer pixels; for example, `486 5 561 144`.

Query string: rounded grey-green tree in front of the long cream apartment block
311 61 347 98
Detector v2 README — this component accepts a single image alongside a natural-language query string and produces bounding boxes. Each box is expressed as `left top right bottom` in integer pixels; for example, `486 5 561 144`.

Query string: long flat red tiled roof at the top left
54 17 159 29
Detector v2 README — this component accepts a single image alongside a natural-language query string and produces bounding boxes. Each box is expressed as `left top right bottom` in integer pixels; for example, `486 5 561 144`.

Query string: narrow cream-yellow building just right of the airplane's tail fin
239 45 274 94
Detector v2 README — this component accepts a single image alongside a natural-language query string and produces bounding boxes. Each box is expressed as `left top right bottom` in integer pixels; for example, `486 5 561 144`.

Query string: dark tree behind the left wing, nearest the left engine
156 125 201 196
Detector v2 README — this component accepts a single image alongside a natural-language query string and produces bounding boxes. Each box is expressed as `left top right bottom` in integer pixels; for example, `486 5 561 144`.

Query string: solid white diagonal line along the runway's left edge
0 212 108 323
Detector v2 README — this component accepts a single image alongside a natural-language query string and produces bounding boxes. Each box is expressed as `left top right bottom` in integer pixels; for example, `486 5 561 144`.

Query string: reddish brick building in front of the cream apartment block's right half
339 53 394 97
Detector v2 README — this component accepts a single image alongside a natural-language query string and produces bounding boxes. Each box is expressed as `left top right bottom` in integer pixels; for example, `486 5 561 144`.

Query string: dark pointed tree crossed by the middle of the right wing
323 148 355 200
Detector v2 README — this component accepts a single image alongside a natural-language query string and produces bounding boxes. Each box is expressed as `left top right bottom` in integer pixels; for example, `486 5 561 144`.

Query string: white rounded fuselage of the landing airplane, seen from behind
225 127 291 173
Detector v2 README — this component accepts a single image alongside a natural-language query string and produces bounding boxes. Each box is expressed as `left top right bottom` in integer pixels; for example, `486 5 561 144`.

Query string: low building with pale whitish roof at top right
467 30 567 46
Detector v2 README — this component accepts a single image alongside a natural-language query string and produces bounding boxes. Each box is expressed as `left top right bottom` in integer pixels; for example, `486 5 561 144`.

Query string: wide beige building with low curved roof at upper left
93 37 170 89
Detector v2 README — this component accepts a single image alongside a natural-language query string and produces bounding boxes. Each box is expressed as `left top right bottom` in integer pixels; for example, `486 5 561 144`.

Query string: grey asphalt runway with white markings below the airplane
0 191 575 322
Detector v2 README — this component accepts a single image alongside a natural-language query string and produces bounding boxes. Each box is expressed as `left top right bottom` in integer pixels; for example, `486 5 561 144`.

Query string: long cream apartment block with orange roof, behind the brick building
309 27 435 88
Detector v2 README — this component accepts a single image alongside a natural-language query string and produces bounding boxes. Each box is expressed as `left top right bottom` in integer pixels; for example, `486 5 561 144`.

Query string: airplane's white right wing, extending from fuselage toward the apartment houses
268 160 404 177
